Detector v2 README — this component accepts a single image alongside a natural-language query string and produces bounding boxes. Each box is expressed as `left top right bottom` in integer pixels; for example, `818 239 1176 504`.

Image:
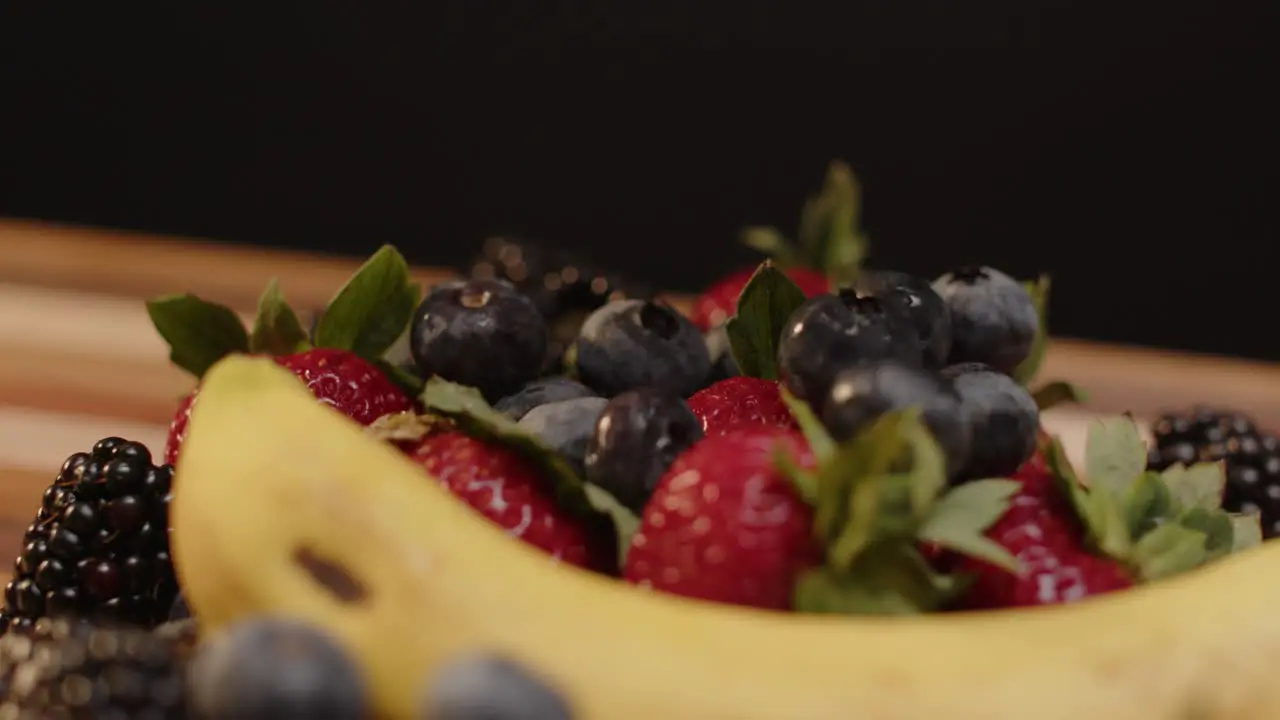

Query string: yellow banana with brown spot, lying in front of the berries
172 357 1280 720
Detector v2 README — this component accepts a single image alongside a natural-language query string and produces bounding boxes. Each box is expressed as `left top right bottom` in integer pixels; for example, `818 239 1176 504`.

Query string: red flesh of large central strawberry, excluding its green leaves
623 427 822 610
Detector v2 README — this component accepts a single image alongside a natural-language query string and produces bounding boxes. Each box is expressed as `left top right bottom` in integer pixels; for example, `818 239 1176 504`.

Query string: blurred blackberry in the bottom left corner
0 619 189 720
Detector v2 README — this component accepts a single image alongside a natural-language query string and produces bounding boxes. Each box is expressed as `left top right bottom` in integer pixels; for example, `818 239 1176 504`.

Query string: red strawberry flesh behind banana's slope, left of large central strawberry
408 432 616 569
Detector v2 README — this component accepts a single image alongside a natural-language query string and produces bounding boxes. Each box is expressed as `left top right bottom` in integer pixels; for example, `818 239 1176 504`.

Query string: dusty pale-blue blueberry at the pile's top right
933 266 1039 374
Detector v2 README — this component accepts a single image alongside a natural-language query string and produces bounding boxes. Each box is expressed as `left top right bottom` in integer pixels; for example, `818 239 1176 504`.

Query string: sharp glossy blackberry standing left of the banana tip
0 437 177 630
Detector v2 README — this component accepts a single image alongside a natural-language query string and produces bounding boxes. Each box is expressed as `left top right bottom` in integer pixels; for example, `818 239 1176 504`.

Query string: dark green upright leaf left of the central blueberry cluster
724 260 805 380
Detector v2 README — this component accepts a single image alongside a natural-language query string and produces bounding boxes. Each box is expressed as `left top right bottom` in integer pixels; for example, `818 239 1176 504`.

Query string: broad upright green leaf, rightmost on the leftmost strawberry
315 245 421 360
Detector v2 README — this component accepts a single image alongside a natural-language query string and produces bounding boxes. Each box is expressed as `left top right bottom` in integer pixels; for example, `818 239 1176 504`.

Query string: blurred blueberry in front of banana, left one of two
191 609 369 720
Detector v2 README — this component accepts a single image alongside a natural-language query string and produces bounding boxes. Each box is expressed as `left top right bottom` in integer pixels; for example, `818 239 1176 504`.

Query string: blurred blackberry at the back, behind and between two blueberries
467 237 653 372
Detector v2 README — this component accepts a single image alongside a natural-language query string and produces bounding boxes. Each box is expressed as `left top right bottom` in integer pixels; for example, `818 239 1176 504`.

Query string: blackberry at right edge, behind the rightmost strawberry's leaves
1147 406 1280 539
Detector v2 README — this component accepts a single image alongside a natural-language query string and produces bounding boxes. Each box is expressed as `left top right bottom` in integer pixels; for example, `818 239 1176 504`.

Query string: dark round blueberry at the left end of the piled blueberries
410 281 547 402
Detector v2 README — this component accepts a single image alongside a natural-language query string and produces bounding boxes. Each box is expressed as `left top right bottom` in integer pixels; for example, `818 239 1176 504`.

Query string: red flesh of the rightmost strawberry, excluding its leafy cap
960 451 1134 609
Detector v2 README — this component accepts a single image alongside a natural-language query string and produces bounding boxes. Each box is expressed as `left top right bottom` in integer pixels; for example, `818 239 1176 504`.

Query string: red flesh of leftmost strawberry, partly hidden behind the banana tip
164 347 413 464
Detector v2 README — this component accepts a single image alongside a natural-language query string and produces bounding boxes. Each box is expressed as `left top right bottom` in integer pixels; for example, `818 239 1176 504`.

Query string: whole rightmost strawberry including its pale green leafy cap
957 407 1261 609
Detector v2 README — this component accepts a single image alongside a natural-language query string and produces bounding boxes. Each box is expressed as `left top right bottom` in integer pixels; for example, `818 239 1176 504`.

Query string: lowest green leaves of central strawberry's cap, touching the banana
792 544 966 615
